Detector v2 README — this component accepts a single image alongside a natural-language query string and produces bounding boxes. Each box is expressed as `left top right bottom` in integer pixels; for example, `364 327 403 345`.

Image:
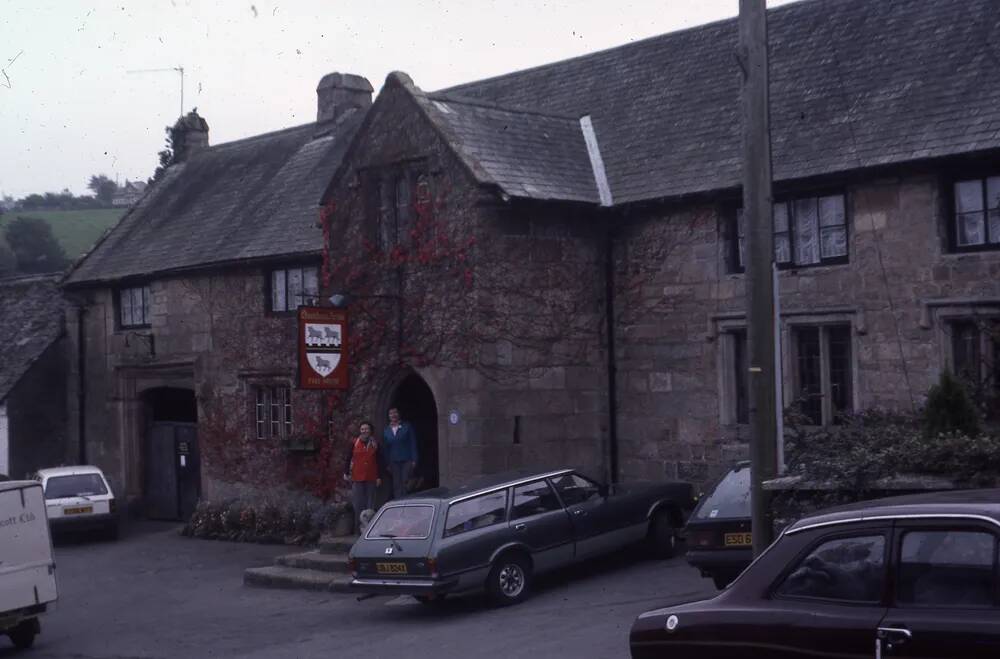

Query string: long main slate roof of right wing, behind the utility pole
431 0 1000 203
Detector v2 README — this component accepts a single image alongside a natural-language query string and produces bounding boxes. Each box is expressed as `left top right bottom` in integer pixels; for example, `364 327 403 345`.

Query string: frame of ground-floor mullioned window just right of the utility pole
786 319 858 426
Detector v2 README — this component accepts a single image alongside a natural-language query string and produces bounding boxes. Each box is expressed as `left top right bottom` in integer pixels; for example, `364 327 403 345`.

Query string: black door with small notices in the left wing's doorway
144 421 201 520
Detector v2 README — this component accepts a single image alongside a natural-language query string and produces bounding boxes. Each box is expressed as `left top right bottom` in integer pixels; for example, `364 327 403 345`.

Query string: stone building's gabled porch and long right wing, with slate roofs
316 0 1000 490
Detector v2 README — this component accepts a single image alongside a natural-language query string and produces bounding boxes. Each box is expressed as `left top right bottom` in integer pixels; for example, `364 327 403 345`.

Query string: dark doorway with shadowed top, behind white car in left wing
142 387 201 520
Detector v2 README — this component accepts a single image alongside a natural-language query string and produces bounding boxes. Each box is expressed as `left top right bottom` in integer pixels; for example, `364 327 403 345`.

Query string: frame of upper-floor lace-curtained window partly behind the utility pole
725 188 852 274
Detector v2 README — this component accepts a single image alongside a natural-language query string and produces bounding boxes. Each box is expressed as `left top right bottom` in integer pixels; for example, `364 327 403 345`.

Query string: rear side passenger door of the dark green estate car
510 480 574 572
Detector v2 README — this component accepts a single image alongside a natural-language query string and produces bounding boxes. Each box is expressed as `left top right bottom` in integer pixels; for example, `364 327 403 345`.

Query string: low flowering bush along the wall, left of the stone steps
181 499 351 545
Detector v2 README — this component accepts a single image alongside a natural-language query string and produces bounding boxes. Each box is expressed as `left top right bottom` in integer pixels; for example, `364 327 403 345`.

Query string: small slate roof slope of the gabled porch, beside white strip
416 90 600 204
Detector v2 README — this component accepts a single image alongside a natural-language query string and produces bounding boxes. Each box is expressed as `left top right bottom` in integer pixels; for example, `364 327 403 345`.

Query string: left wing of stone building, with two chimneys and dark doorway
64 73 372 518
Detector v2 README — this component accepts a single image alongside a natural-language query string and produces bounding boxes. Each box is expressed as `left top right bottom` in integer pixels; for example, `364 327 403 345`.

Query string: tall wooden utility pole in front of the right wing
739 0 777 555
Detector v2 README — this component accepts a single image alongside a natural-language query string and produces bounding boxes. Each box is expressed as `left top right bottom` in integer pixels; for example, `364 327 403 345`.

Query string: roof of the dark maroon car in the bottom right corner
785 489 1000 533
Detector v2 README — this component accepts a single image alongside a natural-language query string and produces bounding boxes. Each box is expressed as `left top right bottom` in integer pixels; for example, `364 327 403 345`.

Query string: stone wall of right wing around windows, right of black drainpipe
615 174 1000 482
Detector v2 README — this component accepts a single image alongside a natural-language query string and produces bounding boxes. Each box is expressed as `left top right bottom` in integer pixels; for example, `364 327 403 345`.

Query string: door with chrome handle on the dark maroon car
879 521 1000 659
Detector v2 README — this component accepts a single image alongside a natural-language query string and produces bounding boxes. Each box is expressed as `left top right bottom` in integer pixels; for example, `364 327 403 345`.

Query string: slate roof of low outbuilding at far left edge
0 275 65 401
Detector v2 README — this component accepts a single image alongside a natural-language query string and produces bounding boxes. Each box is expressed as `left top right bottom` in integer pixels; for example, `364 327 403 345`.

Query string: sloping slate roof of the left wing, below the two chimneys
66 111 363 285
